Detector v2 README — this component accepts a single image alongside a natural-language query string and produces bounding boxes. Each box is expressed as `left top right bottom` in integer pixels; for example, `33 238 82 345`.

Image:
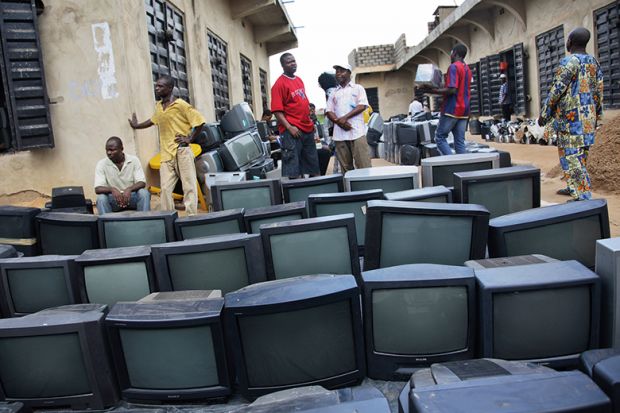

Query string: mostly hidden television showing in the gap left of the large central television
308 189 383 255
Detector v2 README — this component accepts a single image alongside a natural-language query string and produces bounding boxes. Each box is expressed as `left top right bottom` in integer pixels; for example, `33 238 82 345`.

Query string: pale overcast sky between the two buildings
269 0 463 108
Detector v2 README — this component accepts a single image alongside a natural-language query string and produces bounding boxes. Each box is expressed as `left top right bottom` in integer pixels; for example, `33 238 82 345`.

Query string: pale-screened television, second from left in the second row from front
75 246 158 306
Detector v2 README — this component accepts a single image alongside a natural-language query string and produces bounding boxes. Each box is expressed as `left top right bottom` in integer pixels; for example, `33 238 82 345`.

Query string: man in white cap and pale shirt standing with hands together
325 63 372 174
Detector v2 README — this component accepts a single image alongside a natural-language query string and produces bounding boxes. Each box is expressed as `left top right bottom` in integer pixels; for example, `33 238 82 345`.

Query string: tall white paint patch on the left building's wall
92 22 118 99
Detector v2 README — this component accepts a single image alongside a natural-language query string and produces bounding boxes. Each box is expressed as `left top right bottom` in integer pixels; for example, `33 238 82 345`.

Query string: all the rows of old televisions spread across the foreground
0 154 620 412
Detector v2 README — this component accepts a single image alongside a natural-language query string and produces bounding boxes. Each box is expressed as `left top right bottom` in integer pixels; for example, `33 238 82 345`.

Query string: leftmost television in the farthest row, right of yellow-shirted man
211 179 282 211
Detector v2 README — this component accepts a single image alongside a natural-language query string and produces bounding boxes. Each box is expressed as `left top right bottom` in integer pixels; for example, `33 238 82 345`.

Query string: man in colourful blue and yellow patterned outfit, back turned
538 27 603 201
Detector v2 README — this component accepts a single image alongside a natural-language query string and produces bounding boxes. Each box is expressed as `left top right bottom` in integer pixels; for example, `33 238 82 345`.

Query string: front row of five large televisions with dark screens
0 261 612 409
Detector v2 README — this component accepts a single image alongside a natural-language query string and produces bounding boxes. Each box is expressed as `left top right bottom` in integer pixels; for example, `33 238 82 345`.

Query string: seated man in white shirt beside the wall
95 136 151 215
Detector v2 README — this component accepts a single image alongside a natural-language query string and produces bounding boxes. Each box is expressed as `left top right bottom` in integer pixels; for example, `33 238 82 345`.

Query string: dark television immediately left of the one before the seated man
35 212 99 255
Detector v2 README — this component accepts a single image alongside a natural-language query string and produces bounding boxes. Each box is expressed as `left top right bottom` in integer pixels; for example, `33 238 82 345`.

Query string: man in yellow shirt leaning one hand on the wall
129 75 205 215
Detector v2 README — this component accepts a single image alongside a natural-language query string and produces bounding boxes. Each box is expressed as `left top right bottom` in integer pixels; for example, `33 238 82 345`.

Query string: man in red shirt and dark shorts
271 53 319 179
